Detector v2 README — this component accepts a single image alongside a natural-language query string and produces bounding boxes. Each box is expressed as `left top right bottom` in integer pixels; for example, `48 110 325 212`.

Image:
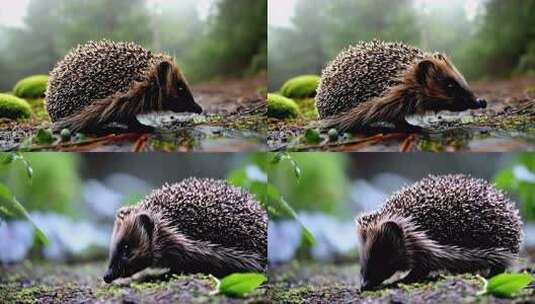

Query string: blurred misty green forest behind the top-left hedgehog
0 0 267 91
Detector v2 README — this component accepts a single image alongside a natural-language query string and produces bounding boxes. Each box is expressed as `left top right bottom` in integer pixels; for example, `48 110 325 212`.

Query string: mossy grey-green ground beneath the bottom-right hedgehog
268 263 535 303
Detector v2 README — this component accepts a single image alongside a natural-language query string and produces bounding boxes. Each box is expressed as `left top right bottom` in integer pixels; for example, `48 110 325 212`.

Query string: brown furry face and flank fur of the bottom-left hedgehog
105 208 264 281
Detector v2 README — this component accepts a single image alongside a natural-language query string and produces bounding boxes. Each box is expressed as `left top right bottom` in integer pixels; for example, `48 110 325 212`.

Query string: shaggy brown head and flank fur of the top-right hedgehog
323 54 482 130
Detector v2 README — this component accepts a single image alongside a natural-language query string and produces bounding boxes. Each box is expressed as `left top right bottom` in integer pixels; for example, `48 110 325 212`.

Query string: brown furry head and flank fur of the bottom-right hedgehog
357 215 516 289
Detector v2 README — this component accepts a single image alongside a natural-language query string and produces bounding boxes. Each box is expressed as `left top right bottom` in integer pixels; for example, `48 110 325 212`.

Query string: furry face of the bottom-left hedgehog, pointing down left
104 210 154 283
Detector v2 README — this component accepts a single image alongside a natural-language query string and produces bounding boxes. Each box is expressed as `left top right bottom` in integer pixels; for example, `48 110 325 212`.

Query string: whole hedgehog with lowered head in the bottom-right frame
356 175 522 290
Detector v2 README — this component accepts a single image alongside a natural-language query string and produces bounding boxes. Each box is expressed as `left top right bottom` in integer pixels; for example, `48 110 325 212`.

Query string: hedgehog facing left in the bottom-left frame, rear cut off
104 178 267 283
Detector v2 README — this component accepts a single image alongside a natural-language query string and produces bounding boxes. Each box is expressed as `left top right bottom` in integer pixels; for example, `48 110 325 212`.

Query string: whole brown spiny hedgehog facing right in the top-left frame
45 40 202 131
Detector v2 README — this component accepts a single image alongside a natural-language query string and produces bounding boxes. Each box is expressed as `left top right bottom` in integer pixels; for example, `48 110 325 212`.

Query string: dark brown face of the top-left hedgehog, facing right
158 61 202 114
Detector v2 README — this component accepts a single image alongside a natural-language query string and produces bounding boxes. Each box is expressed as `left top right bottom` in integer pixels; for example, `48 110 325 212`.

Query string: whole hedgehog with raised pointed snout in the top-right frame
316 40 487 130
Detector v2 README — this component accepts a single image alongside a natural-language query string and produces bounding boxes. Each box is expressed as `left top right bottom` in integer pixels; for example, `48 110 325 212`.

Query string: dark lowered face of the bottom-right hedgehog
360 222 406 290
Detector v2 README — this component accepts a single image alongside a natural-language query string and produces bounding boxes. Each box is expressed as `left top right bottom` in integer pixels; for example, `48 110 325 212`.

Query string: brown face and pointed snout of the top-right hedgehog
416 54 487 112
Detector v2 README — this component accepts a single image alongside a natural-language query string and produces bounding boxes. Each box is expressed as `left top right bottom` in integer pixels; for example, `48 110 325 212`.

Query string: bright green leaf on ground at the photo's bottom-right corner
484 273 533 298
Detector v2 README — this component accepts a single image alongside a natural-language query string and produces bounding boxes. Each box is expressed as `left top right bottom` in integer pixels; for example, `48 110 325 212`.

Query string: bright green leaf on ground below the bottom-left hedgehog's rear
218 273 267 298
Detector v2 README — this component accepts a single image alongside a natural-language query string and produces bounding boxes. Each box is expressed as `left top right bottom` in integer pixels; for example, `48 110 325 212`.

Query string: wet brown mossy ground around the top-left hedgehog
0 75 267 152
